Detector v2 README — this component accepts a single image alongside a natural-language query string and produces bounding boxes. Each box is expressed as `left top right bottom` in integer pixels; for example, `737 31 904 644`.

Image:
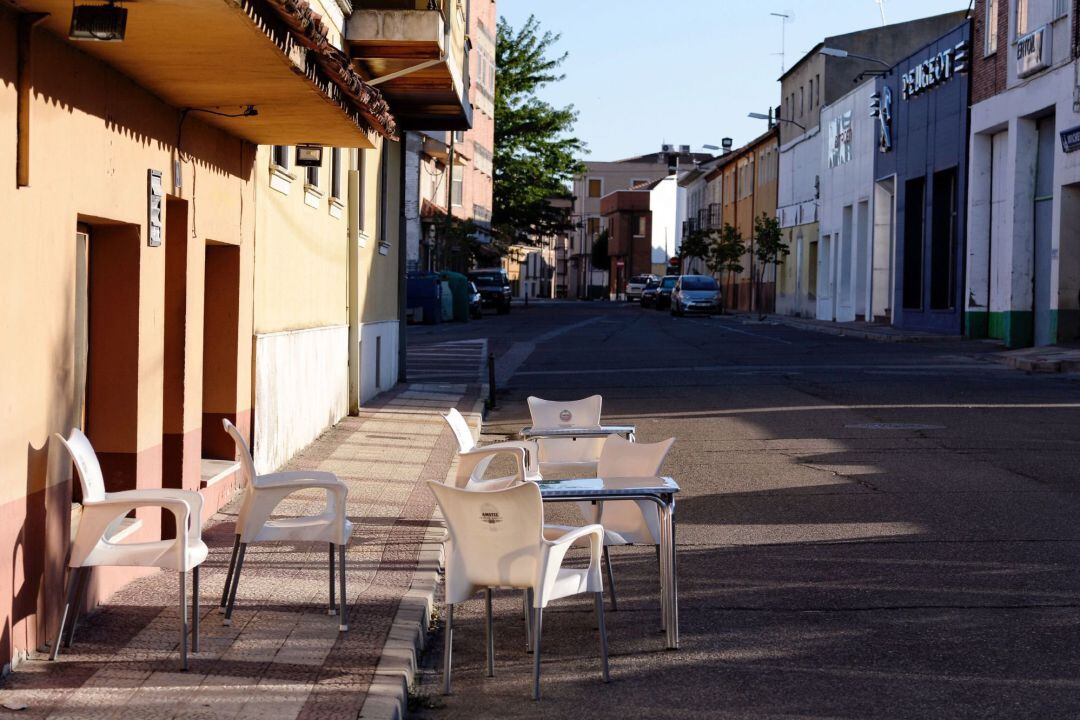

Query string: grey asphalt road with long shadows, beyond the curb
409 303 1080 718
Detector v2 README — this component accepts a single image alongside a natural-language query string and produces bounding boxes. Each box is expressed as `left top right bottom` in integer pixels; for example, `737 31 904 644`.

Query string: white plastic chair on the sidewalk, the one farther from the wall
221 419 352 631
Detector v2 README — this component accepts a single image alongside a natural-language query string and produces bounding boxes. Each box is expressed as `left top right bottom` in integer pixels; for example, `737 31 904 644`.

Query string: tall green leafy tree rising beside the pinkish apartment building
491 15 585 247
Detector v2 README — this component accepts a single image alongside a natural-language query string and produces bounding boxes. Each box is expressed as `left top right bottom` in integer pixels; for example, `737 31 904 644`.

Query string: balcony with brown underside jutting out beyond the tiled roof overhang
346 0 472 130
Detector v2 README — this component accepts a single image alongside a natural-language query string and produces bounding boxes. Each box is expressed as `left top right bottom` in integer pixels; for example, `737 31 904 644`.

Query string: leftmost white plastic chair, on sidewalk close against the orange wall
50 427 208 670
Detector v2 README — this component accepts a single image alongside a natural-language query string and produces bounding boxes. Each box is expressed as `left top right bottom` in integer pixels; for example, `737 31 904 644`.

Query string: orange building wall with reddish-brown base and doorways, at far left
0 8 255 664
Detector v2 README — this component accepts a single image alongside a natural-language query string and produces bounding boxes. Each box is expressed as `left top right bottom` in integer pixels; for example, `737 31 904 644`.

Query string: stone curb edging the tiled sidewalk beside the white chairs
357 396 484 720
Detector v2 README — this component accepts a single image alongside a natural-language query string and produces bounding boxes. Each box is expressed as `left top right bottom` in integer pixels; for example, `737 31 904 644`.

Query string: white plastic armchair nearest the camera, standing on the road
428 480 609 699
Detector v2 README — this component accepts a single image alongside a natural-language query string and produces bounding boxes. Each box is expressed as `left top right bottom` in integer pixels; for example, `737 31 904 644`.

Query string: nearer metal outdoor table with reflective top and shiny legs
537 477 679 650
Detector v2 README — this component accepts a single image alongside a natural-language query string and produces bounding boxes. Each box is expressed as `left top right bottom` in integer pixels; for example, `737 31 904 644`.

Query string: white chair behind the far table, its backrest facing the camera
528 395 605 476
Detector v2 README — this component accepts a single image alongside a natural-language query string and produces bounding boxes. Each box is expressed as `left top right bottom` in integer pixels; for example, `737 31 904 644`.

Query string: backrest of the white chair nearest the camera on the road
428 480 543 602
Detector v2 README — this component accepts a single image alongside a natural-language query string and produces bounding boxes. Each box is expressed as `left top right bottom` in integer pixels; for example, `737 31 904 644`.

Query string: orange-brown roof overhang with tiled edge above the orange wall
14 0 396 148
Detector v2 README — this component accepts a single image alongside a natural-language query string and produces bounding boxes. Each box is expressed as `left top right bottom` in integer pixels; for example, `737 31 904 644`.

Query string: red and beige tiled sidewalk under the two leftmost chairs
0 384 478 720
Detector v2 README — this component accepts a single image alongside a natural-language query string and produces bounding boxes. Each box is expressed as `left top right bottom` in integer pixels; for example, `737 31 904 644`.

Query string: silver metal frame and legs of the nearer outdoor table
537 477 679 650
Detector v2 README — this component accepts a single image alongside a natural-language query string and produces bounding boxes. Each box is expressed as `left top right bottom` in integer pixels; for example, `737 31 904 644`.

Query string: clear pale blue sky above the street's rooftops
497 0 969 160
